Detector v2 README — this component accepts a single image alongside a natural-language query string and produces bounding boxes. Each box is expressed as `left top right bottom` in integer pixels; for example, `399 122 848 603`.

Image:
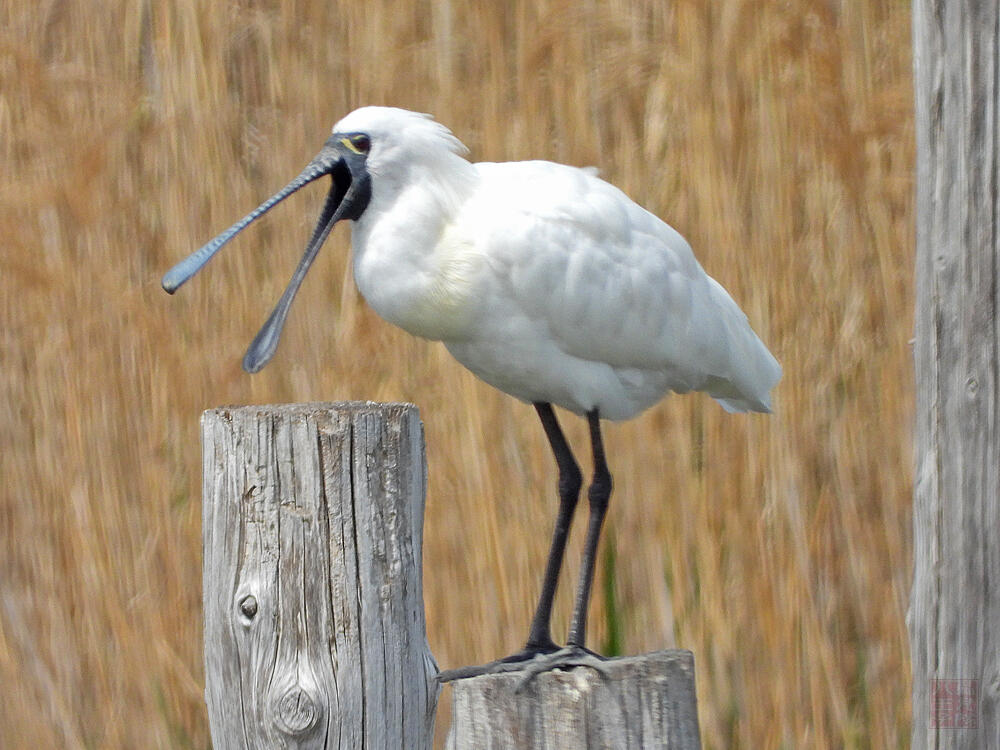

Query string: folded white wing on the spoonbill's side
464 162 780 408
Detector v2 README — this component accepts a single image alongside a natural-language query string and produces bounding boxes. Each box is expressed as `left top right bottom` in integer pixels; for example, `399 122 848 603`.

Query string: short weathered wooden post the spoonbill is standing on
448 650 701 750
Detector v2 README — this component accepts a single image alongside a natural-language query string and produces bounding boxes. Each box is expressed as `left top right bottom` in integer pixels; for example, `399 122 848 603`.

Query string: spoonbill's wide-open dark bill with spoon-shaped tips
161 135 371 373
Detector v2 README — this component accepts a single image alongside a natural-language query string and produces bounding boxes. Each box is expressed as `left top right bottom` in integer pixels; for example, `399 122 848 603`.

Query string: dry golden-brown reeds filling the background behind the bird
0 0 913 748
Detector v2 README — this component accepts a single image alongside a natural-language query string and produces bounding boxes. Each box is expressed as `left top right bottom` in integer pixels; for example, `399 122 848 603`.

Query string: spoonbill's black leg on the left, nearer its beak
525 403 583 651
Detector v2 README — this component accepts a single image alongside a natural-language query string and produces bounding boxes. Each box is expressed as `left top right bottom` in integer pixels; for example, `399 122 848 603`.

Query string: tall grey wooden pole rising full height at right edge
909 0 1000 750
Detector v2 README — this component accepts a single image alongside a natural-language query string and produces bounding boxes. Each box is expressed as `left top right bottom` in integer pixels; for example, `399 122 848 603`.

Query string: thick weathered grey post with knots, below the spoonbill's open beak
202 403 439 750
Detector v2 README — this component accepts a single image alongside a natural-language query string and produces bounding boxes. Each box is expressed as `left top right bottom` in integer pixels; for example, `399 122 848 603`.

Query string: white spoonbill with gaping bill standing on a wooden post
163 107 781 680
